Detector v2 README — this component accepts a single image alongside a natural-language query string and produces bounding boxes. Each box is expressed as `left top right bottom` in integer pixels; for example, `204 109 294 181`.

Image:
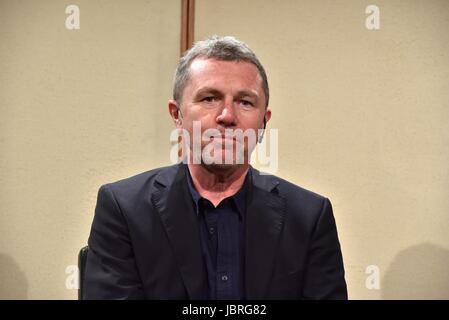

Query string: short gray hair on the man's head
173 35 270 106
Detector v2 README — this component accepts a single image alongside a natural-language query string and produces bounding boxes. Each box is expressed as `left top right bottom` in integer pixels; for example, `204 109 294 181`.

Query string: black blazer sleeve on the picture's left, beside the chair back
83 185 144 299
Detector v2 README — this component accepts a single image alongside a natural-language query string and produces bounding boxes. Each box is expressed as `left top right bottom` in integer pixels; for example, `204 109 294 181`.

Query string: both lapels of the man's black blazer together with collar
152 163 285 299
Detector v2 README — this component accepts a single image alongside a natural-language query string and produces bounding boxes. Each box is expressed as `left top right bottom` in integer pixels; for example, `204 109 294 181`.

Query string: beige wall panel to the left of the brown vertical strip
0 0 181 299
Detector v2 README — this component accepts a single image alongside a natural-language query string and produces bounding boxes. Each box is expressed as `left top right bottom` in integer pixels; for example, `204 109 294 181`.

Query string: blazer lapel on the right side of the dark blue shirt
245 168 285 299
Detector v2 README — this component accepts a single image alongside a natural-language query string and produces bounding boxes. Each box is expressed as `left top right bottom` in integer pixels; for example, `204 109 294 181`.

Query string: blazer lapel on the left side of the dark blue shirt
152 164 207 299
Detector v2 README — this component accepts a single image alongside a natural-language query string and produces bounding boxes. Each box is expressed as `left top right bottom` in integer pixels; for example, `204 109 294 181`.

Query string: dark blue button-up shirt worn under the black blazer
187 169 249 300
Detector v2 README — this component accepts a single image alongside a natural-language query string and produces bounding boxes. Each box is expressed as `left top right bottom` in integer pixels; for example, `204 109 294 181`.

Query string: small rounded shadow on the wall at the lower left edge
0 253 28 300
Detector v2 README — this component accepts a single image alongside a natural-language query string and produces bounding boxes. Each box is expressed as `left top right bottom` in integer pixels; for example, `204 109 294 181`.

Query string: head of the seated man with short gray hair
169 36 271 168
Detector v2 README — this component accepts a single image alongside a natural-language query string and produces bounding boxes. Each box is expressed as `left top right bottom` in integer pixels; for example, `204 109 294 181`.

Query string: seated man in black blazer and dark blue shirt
84 36 347 299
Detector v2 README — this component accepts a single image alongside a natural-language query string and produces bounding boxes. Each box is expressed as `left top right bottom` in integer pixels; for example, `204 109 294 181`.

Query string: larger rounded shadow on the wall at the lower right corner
381 243 449 299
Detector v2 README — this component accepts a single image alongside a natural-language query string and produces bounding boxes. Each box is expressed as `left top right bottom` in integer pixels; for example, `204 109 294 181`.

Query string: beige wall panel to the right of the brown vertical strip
196 0 449 299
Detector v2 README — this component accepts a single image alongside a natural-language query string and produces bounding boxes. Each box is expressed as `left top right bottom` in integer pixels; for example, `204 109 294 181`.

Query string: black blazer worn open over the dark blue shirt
84 164 347 299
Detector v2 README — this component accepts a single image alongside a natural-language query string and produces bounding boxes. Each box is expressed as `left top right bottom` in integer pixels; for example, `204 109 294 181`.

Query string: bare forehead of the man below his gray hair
189 58 262 91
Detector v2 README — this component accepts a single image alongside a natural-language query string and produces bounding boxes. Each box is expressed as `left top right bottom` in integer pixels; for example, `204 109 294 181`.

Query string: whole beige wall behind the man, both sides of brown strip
0 0 449 299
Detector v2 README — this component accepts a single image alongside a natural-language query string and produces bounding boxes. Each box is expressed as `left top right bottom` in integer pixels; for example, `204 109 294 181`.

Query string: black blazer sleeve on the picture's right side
303 199 348 300
